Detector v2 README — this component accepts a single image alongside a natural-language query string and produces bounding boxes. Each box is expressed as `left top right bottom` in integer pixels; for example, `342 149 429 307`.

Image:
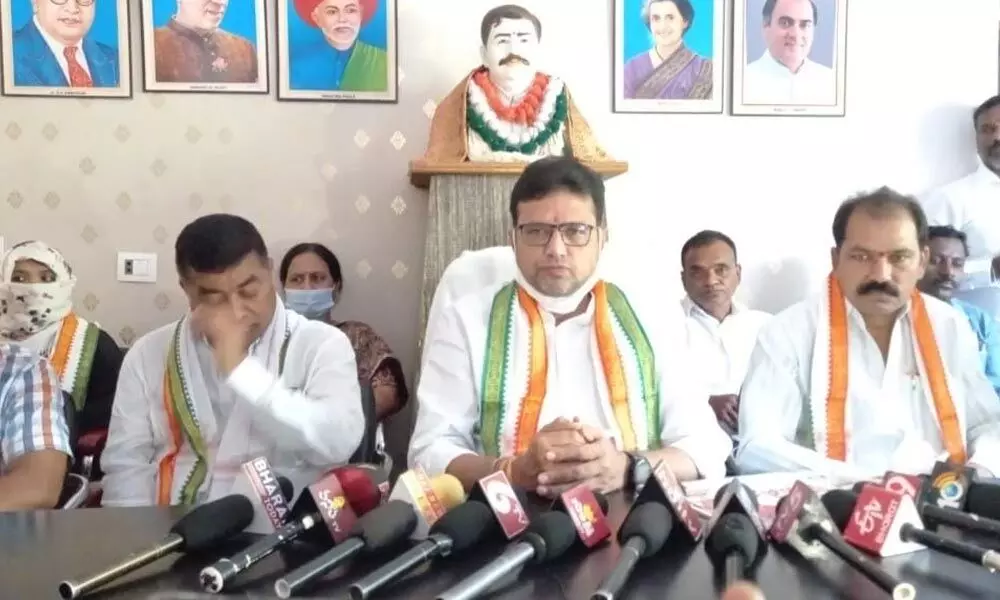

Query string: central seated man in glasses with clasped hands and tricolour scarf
410 157 732 497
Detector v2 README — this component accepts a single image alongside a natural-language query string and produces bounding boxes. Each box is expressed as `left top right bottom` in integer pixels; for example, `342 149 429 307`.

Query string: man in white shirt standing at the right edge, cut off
923 96 1000 281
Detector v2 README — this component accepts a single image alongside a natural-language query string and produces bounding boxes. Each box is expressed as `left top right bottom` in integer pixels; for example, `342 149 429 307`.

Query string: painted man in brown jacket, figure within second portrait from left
153 0 263 83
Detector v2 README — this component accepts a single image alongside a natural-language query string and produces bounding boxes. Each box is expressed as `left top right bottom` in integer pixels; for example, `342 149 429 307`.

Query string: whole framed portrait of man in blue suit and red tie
0 0 132 98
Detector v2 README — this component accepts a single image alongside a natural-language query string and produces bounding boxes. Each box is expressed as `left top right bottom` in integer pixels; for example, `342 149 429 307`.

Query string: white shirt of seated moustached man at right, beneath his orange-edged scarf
736 295 1000 478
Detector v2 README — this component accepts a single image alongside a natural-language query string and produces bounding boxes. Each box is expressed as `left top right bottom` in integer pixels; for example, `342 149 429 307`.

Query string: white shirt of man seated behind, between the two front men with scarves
681 296 771 396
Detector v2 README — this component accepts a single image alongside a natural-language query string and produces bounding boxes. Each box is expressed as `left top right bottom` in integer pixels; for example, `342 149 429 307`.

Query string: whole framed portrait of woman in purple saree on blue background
613 0 727 113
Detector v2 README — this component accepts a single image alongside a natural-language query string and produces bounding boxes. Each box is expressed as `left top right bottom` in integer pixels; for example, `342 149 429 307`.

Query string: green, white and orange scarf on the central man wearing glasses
479 281 661 456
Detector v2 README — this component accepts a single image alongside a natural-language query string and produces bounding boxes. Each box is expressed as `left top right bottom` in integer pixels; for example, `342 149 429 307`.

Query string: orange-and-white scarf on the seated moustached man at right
798 275 966 464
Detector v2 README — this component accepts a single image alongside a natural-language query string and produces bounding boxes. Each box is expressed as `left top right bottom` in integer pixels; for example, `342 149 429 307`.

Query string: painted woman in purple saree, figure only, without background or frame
625 0 712 100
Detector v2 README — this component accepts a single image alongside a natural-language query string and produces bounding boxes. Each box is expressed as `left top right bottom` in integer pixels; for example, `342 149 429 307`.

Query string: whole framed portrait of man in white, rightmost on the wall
732 0 848 117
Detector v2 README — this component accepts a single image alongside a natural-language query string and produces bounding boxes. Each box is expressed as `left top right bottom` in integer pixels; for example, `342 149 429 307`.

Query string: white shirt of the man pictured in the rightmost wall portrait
742 51 837 106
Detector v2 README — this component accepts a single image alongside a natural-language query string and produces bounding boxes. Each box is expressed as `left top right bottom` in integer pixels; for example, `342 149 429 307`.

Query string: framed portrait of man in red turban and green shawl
277 0 399 102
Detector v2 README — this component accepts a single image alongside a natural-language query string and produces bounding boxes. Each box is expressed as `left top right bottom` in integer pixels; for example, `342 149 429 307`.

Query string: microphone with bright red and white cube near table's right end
823 485 1000 571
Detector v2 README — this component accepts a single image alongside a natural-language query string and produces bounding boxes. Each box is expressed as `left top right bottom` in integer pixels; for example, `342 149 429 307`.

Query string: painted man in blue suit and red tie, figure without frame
12 0 119 88
